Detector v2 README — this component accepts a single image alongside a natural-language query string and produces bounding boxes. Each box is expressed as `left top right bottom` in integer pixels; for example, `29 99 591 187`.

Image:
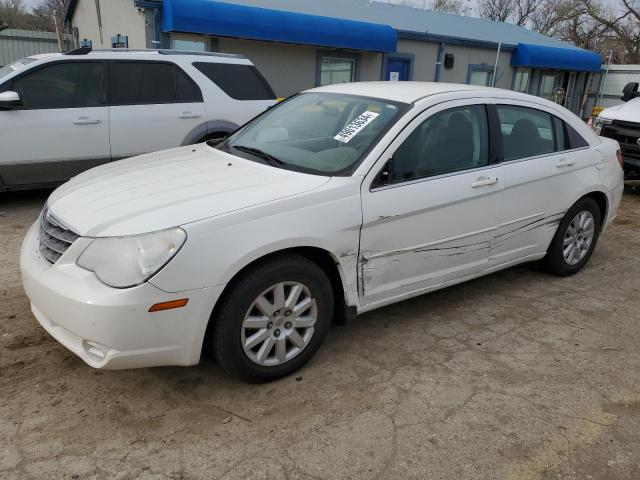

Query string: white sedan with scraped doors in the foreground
21 82 623 382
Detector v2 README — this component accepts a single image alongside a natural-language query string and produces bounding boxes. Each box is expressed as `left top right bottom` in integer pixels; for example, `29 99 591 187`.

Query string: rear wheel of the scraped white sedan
542 197 602 277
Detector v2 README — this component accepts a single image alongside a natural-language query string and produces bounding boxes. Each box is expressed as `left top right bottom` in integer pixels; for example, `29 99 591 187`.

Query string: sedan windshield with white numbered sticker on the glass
218 93 408 175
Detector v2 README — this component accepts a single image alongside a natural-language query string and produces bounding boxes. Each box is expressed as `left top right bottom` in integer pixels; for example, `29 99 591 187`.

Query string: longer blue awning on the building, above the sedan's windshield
163 0 397 52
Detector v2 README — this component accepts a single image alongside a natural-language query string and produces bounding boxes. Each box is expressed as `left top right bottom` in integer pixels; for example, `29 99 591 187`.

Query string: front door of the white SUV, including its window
0 61 110 186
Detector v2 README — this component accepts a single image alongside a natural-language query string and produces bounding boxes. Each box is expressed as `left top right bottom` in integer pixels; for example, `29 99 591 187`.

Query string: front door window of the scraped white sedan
391 105 489 183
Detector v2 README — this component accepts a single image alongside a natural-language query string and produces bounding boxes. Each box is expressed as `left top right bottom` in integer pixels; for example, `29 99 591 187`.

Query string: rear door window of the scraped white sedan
497 105 555 160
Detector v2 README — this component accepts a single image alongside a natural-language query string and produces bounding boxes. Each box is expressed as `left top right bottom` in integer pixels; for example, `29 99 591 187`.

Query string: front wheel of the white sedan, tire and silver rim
212 253 333 383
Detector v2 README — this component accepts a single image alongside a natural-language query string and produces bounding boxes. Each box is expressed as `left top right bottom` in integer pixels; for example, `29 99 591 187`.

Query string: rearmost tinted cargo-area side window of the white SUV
193 62 276 100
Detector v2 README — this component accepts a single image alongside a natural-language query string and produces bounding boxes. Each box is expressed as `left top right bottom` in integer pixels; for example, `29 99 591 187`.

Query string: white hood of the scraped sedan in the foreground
47 144 330 237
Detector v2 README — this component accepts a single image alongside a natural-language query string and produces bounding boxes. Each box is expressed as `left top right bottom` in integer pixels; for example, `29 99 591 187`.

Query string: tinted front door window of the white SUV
11 62 104 109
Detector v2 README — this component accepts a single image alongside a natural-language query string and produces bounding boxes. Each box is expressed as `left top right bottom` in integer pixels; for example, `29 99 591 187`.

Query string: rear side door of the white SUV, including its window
109 60 206 160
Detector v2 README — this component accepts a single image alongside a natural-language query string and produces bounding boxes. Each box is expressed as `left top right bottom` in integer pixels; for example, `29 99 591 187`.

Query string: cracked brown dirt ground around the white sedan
0 191 640 480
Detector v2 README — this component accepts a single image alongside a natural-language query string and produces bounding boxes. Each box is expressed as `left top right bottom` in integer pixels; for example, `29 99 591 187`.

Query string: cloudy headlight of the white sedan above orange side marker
76 228 187 288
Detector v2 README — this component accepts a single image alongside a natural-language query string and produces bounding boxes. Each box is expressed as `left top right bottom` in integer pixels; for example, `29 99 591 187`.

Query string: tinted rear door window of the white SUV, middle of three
110 61 202 105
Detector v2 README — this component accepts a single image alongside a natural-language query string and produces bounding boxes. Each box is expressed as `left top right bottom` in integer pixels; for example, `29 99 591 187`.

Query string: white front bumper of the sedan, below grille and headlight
20 223 223 369
